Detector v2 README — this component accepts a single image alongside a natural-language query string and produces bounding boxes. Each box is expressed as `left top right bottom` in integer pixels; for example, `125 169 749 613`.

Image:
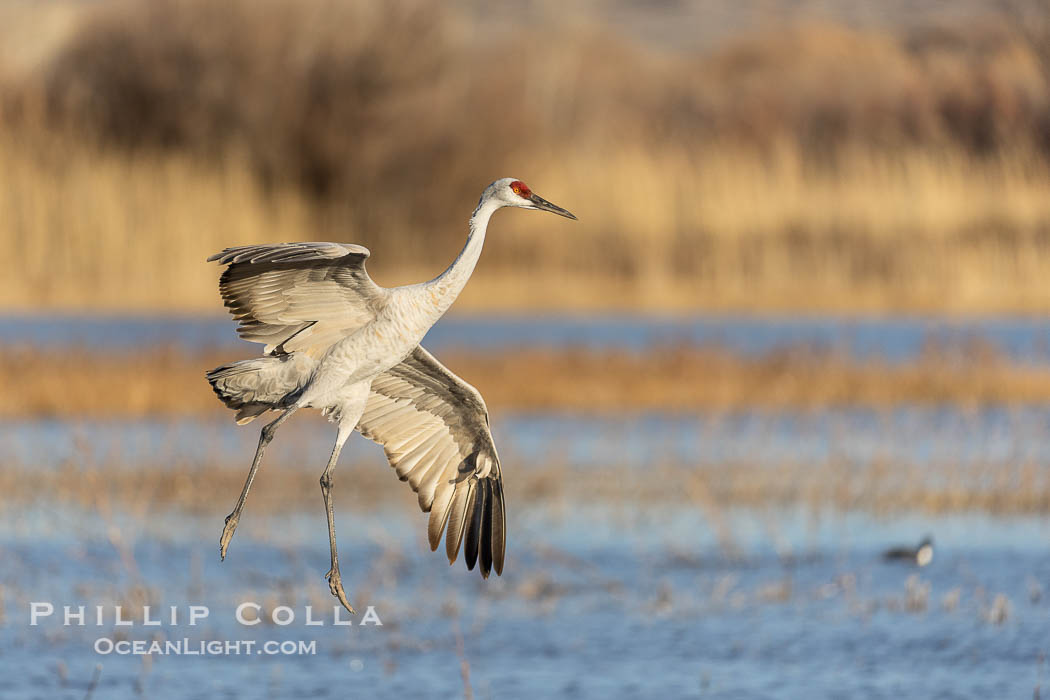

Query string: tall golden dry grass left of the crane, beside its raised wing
0 134 312 310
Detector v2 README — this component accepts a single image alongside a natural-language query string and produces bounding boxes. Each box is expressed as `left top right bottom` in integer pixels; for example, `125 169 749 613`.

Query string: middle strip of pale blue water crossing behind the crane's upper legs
6 405 1050 470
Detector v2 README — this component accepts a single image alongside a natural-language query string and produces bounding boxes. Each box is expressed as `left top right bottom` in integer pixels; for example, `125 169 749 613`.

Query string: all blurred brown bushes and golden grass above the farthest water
0 0 1050 313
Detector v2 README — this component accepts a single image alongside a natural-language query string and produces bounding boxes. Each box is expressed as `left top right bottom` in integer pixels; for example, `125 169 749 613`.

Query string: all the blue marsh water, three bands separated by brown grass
0 318 1050 700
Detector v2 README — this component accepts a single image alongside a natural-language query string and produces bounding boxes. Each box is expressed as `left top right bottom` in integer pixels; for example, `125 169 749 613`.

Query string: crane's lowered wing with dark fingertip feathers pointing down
357 345 506 578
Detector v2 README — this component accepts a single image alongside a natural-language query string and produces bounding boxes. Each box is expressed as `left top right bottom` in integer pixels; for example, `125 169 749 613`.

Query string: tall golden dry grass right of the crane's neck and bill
506 145 1050 314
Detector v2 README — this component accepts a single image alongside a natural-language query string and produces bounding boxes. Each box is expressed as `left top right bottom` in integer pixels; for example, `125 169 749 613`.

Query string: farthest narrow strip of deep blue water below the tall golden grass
10 315 1050 363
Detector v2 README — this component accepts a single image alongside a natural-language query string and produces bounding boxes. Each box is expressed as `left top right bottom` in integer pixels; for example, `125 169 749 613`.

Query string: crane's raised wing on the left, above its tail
208 242 386 357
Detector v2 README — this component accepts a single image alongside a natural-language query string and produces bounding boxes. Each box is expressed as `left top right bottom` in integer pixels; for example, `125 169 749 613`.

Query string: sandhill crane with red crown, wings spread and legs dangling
207 177 575 613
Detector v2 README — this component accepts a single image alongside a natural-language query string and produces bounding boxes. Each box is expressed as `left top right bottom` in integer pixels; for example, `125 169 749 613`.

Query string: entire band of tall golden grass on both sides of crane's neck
6 134 1050 313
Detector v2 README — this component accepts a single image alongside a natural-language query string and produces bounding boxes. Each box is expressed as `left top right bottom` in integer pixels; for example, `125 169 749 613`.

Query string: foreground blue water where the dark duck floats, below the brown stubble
0 507 1050 698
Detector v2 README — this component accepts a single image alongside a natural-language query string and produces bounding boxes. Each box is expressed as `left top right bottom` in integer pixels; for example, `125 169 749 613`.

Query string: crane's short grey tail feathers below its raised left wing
205 353 313 425
